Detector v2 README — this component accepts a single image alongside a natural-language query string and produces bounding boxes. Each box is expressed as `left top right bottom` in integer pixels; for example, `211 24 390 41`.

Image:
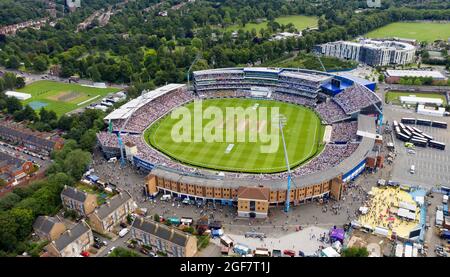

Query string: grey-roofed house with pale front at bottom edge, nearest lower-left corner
47 220 94 257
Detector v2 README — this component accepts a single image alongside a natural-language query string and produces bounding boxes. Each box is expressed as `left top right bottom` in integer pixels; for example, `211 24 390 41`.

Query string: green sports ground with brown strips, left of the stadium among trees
18 80 119 116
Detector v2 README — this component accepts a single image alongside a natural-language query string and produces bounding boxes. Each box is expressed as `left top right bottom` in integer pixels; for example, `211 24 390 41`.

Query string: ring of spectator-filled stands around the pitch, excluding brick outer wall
97 68 381 189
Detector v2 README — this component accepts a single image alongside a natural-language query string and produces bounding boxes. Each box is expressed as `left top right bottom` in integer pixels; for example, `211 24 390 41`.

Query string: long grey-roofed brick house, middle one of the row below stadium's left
89 191 137 233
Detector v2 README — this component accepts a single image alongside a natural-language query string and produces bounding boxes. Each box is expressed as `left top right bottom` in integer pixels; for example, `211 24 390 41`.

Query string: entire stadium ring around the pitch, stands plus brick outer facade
97 68 382 217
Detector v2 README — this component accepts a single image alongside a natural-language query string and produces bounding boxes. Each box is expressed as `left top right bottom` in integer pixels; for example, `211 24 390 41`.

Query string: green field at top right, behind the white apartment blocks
365 22 450 42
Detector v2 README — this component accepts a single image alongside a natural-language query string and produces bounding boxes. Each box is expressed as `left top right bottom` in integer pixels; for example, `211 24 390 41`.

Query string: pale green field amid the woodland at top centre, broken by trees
225 15 318 35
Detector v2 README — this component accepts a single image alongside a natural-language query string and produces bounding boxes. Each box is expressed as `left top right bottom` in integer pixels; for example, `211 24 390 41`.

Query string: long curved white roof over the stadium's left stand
105 84 186 120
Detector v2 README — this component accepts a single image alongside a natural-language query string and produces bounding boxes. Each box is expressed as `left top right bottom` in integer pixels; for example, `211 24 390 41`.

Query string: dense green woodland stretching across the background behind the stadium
0 0 450 86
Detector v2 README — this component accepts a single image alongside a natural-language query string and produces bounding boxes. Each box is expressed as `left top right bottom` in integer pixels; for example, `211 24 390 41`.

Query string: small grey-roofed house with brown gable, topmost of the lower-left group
61 186 97 216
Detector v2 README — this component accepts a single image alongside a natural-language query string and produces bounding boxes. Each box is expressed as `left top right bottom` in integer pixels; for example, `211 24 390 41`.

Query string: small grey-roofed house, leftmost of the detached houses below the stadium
33 216 66 241
